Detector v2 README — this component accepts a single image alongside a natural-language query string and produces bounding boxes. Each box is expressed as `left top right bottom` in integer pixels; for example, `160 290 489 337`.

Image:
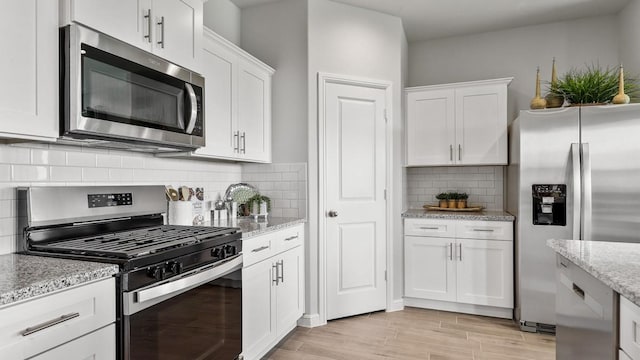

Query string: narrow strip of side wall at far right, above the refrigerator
618 0 640 77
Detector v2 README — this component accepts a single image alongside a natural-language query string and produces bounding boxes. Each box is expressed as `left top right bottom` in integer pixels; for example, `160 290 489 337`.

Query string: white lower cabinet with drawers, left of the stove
0 278 116 360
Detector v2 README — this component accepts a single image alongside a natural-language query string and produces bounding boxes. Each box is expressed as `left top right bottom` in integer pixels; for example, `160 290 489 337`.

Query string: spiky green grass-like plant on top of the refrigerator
549 65 639 105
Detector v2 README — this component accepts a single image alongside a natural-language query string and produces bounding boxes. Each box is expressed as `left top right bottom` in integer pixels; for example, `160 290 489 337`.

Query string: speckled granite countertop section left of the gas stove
0 254 118 307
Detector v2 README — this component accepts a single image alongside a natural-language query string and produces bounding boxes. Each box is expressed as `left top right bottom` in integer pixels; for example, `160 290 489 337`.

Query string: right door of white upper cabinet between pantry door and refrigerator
455 85 507 165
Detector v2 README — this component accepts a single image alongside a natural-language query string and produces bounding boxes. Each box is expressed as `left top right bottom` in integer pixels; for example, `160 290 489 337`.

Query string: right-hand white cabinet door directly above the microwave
153 0 203 71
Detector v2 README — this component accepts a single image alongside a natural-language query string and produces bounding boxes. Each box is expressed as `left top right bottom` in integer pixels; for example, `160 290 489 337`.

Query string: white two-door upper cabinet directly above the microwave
61 0 203 71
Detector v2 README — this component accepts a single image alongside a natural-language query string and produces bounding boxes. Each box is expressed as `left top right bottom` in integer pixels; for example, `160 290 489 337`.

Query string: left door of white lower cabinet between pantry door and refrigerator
404 236 456 301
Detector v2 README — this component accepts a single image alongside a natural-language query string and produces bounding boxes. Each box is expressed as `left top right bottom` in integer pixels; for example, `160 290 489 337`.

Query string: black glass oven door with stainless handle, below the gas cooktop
121 255 242 360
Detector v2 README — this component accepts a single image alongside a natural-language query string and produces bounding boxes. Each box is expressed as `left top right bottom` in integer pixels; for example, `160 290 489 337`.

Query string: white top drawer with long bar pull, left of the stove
0 278 116 359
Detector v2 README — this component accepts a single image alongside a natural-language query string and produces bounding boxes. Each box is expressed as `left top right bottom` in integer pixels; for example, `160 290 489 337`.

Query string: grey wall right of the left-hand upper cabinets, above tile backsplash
242 0 307 163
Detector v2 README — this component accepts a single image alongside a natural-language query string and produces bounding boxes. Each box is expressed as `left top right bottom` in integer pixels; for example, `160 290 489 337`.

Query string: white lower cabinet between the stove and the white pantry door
242 224 304 360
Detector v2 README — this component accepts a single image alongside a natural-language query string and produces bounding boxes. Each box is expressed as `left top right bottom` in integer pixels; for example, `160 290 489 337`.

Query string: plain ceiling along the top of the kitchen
231 0 638 42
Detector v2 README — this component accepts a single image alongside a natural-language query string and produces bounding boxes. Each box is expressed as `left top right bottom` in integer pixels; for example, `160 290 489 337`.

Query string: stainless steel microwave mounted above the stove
60 24 205 152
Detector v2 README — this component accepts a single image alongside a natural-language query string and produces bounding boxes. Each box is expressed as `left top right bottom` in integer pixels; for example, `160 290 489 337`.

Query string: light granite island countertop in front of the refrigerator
547 239 640 306
